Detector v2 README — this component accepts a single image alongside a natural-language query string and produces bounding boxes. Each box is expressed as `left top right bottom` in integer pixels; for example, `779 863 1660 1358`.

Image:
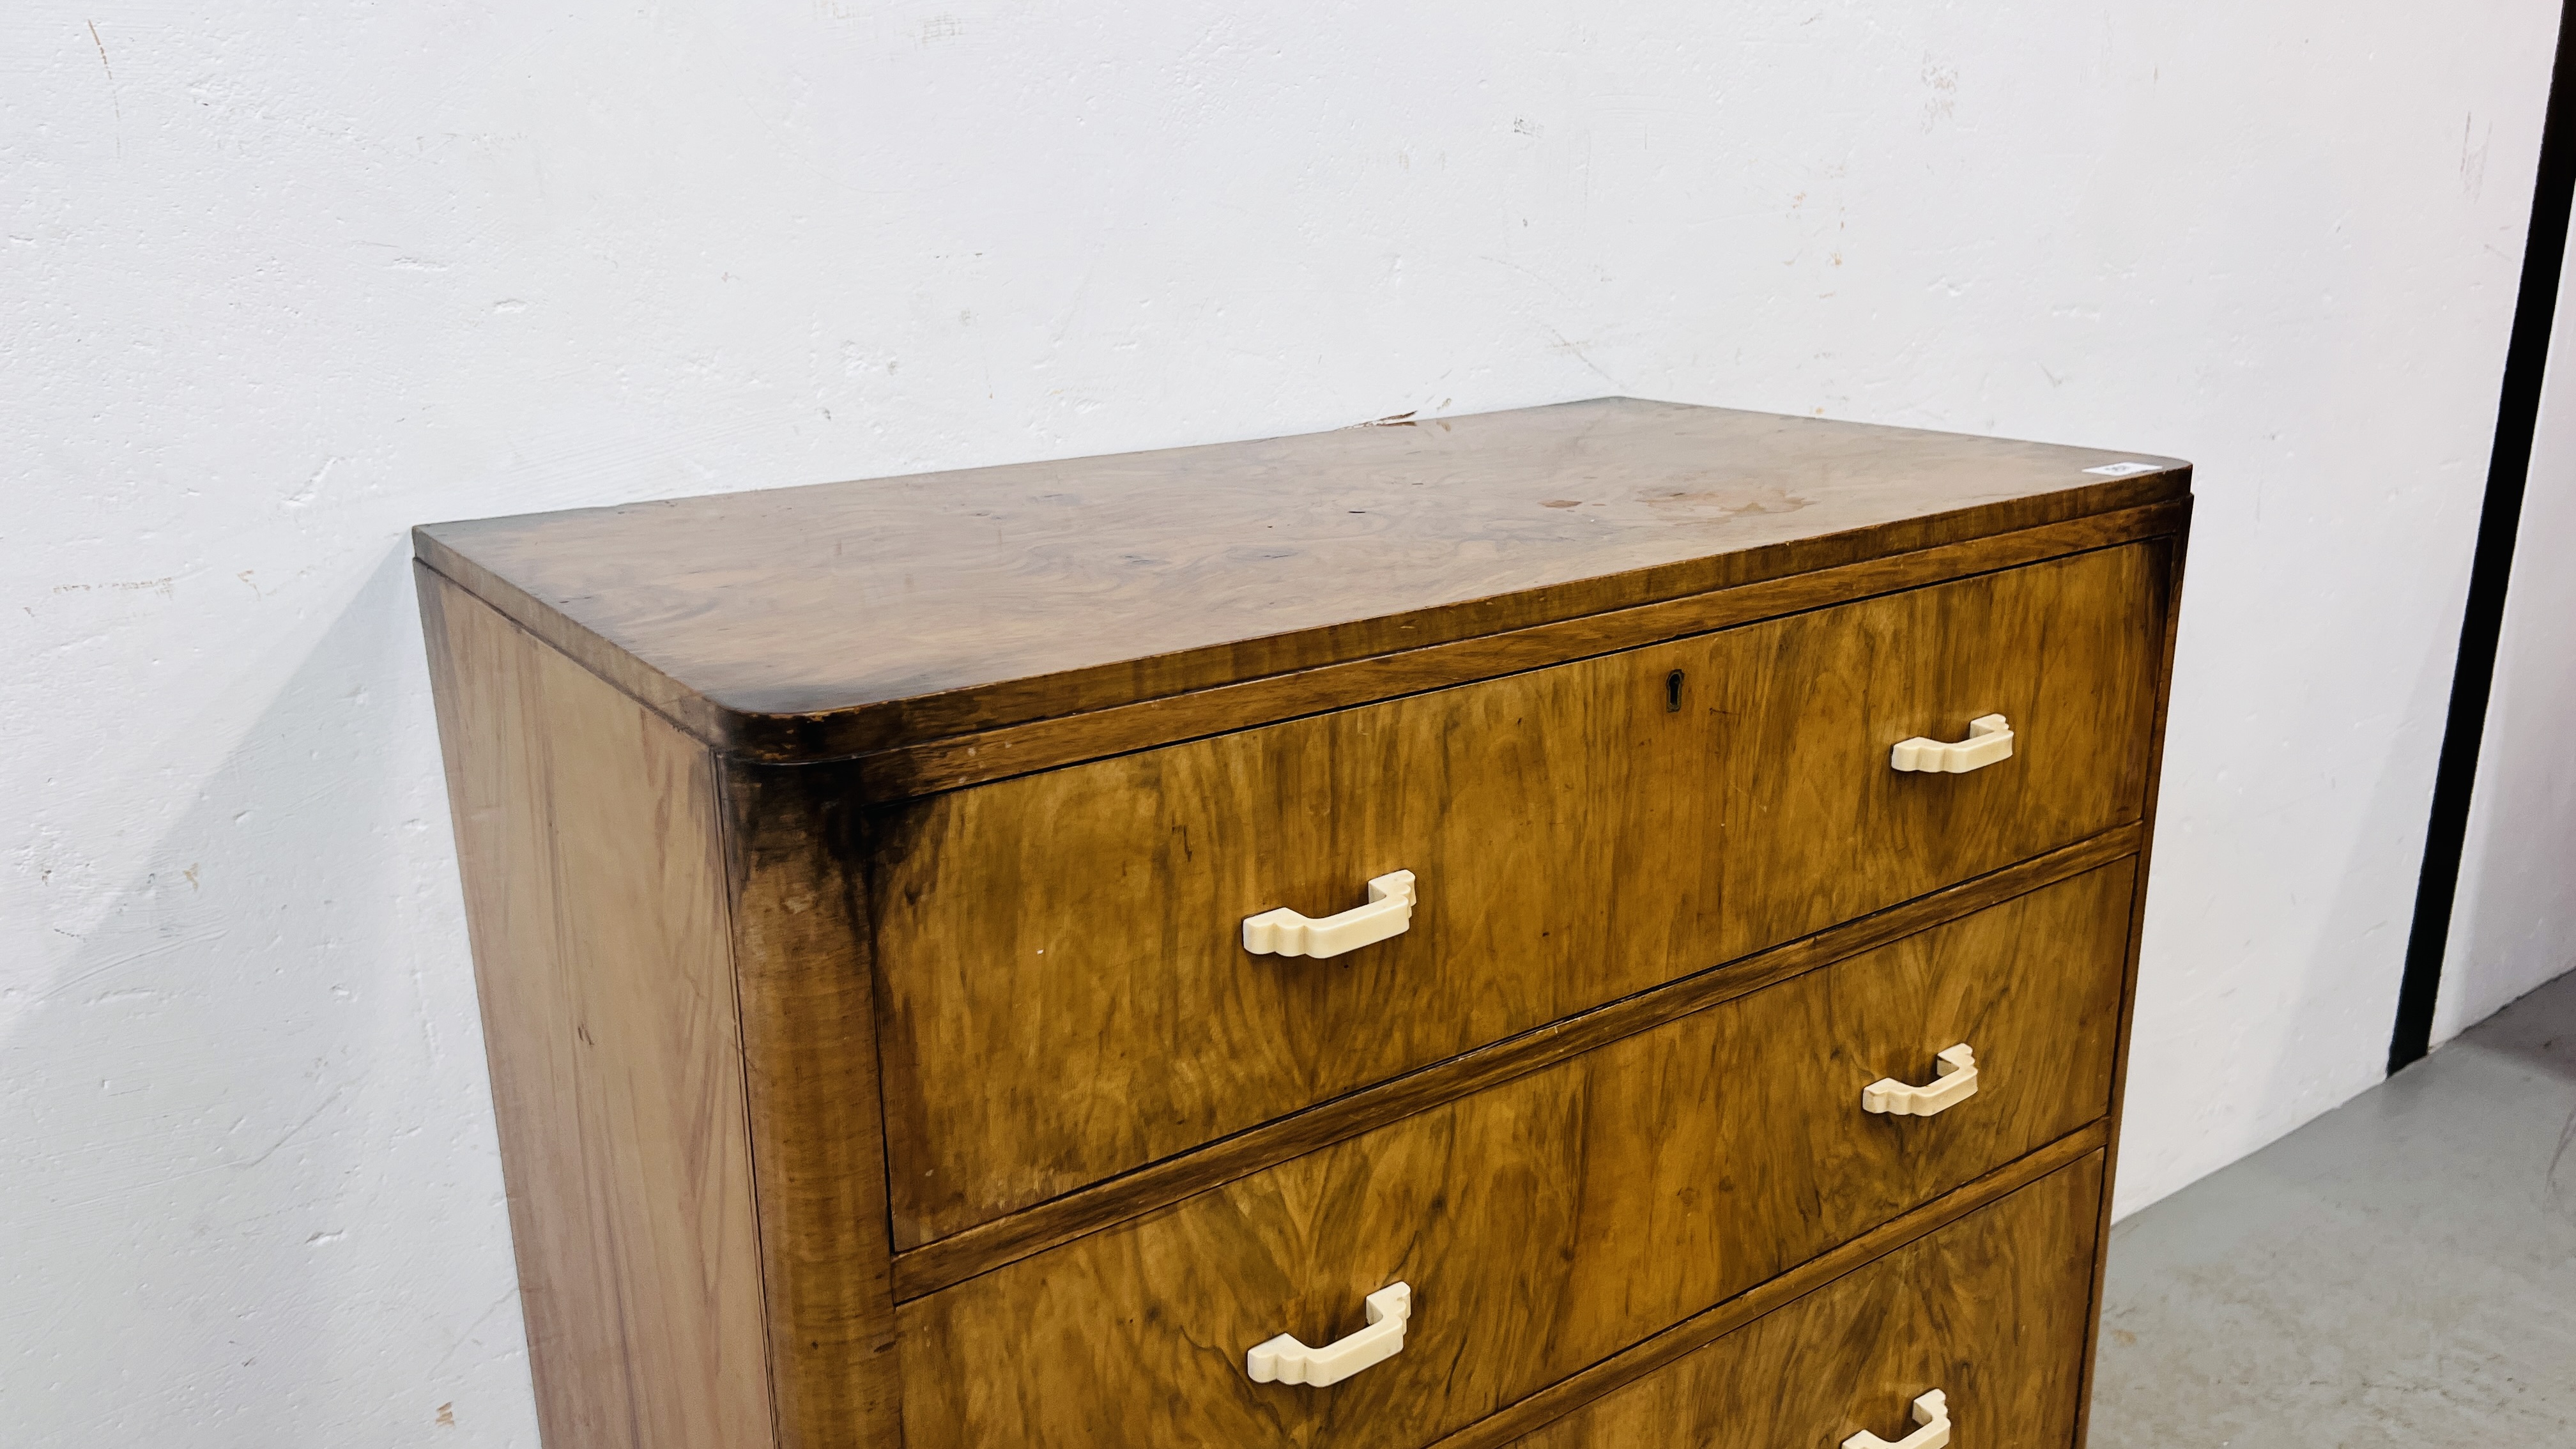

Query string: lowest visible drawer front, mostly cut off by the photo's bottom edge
1512 1153 2102 1449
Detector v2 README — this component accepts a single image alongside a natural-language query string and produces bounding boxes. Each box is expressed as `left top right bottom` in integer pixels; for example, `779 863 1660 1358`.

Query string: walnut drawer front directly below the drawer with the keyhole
899 859 2136 1449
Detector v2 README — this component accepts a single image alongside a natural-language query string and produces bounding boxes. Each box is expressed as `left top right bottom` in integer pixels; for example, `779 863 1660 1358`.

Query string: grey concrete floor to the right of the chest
2092 974 2576 1449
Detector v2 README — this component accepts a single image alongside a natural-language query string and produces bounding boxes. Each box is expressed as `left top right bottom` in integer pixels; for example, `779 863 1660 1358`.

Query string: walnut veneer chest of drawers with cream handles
417 400 2189 1449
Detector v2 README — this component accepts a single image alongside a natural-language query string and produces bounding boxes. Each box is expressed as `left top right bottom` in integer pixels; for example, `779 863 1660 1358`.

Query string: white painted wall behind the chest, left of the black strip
0 0 2563 1449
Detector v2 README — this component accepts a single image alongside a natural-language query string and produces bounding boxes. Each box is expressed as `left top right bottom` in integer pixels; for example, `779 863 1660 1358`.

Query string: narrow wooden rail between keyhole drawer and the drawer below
894 825 2141 1300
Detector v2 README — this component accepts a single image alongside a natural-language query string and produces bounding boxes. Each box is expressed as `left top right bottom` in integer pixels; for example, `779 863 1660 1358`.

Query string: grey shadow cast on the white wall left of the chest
0 549 536 1449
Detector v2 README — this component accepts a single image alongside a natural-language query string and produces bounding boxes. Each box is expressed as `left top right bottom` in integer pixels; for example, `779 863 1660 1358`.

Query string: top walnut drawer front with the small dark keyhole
868 541 2169 1248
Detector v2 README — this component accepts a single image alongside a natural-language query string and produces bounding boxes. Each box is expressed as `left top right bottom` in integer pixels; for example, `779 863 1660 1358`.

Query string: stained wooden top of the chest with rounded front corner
415 400 2189 760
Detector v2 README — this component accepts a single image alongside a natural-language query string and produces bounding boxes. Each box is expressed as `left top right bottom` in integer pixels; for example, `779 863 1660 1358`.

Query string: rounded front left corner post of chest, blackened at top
724 760 901 1449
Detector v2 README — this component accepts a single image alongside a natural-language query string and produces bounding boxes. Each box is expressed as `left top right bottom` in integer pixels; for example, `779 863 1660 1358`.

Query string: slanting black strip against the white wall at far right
2388 0 2576 1073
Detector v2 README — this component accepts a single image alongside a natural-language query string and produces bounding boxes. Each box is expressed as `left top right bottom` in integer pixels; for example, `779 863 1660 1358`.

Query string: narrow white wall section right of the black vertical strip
2432 197 2576 1044
